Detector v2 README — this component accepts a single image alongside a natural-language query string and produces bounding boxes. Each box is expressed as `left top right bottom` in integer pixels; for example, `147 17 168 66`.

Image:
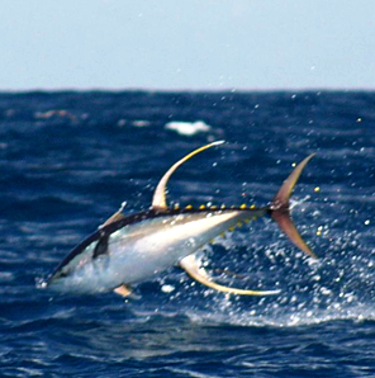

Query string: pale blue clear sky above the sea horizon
0 0 375 91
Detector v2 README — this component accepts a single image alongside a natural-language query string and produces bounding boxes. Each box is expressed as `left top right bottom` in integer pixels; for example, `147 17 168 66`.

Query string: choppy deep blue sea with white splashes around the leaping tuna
0 92 375 378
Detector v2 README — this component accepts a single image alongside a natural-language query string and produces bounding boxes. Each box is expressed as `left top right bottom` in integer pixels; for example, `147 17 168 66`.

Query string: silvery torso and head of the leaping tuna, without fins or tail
49 208 267 293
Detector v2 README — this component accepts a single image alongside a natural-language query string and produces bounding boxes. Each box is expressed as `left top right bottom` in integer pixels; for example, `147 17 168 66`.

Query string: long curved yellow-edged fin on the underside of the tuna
180 255 280 295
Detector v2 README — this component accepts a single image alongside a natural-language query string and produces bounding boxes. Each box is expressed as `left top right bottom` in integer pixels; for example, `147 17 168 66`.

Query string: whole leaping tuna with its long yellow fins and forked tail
44 142 316 296
